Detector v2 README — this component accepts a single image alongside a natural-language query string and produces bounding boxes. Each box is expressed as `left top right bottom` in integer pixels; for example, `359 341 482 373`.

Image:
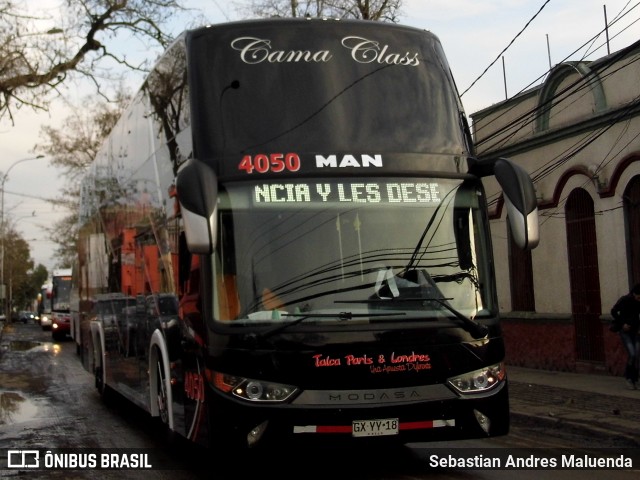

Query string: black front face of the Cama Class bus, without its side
172 20 532 445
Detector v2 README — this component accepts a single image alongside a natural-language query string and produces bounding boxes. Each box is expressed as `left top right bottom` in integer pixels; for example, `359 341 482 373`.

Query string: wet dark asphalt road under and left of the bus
0 324 638 480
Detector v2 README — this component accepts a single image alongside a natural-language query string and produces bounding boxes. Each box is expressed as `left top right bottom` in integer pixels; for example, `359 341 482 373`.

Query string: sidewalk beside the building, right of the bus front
507 366 640 448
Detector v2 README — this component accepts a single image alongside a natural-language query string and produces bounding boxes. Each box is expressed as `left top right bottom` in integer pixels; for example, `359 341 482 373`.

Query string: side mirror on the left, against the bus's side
176 159 218 254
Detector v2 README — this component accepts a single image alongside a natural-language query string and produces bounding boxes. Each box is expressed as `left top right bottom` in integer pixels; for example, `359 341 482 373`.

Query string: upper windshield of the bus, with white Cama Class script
189 22 466 162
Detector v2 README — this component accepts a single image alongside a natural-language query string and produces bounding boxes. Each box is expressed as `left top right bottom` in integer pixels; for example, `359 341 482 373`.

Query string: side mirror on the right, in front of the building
494 158 540 250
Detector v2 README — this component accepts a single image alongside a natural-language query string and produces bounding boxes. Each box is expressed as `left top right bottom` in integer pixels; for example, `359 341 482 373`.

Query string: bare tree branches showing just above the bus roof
240 0 402 23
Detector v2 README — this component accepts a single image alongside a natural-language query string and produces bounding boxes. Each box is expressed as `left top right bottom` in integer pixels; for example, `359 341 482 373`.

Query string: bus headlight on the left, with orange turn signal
212 372 298 403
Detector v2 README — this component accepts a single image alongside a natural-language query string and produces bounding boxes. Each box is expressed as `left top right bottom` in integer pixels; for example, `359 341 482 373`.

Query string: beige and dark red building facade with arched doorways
471 42 640 375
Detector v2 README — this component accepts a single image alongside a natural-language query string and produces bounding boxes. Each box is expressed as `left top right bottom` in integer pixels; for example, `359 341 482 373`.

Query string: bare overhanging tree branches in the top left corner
0 0 183 123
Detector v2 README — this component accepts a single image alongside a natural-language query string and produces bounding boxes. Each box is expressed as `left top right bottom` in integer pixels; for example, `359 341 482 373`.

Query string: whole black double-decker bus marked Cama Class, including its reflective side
77 19 538 448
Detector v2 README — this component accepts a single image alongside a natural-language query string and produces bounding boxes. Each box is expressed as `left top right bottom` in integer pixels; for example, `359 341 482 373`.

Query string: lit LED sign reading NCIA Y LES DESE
253 181 441 205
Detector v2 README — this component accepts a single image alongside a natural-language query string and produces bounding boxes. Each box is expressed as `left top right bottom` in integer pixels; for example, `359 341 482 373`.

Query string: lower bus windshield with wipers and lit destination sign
214 178 495 326
